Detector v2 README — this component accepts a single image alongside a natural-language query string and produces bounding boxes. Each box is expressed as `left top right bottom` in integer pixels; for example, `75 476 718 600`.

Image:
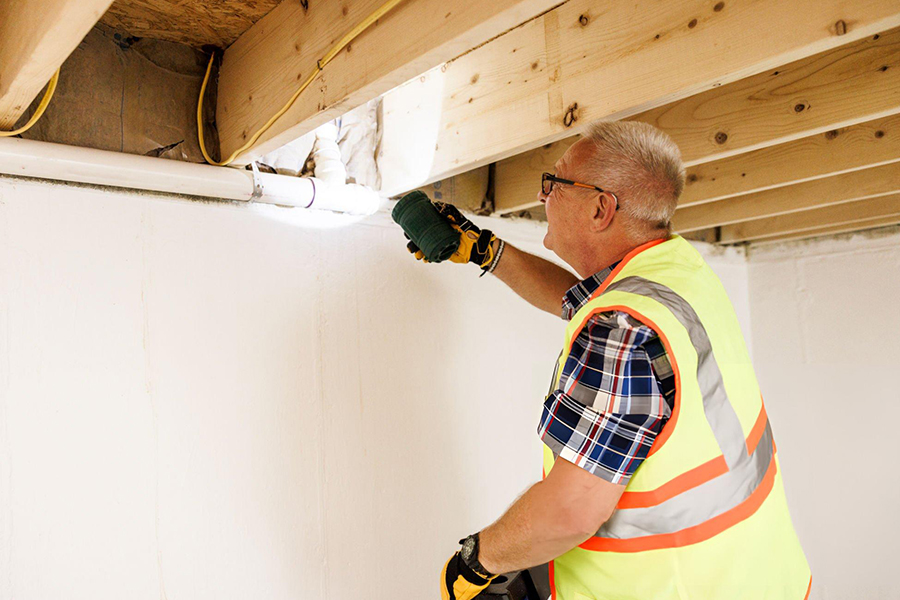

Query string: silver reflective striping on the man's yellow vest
597 276 774 539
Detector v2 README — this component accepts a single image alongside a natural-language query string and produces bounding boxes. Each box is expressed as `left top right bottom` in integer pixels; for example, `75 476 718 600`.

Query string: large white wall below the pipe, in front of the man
0 180 752 600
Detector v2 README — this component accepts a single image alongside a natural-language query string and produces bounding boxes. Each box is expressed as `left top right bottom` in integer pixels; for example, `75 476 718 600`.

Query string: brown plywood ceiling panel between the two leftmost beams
100 0 281 48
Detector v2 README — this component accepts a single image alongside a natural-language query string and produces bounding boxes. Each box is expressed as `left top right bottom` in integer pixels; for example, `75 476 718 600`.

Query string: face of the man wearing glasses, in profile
538 140 596 264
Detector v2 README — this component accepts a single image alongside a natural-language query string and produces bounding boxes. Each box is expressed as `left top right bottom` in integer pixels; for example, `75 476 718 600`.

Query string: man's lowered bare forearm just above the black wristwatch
478 482 593 574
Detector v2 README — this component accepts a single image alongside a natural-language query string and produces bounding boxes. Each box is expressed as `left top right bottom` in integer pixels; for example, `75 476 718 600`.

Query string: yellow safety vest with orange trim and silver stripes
544 236 811 600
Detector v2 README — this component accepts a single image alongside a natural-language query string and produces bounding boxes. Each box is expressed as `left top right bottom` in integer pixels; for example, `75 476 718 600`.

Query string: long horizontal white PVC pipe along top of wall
0 138 381 215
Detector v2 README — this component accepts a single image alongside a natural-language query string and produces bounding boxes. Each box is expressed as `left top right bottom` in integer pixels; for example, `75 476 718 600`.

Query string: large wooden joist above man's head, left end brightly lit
383 0 900 193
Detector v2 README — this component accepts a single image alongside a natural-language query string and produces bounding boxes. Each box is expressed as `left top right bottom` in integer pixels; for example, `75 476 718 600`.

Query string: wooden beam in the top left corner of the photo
0 0 112 130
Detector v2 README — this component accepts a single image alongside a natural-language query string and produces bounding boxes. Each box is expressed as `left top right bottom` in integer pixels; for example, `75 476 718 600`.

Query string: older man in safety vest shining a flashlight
410 122 811 600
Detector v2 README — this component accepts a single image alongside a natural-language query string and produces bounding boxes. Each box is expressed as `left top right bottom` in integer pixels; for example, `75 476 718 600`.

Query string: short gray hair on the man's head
584 121 684 236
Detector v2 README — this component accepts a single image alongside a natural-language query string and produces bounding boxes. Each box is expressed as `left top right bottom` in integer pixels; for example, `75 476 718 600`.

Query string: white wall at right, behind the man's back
749 230 900 600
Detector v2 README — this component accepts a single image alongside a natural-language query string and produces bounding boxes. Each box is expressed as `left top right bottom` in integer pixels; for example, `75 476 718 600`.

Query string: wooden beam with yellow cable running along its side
216 0 558 163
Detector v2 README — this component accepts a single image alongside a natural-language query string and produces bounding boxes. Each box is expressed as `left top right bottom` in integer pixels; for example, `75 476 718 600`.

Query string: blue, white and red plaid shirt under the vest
538 265 675 485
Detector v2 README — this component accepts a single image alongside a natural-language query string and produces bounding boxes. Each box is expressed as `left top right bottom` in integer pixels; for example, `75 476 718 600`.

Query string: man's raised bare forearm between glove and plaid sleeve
494 243 578 316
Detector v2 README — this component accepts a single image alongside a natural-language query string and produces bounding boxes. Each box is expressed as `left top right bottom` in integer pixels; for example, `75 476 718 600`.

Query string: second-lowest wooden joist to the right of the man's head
674 162 900 232
